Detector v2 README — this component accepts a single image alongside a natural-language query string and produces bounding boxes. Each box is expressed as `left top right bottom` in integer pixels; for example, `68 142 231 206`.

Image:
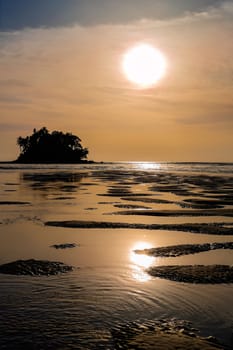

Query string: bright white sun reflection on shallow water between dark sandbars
129 242 155 282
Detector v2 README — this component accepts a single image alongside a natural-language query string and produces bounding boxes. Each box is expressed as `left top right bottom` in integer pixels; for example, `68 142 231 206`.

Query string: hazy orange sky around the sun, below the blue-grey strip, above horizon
0 2 233 162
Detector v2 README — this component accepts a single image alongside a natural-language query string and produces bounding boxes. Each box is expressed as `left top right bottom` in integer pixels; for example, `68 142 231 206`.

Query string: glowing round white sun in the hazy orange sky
122 43 167 88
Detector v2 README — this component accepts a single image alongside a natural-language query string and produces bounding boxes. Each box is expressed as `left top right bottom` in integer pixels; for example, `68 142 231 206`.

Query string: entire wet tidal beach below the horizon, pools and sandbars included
0 162 233 350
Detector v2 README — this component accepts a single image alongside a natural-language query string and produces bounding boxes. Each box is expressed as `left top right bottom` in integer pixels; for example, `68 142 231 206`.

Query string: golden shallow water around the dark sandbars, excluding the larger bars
0 162 233 349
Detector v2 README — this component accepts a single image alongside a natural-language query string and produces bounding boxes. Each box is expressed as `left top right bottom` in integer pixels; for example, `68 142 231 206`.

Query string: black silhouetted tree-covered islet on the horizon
16 127 88 163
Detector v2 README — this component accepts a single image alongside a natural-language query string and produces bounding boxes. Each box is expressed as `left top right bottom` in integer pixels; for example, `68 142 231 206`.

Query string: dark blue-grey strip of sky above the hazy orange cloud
0 0 224 31
